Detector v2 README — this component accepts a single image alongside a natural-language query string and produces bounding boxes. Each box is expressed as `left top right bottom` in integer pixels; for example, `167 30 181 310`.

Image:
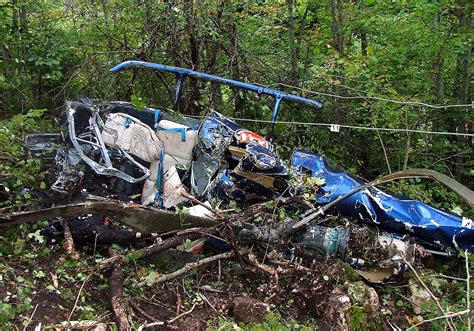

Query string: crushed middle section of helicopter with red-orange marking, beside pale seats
191 112 288 204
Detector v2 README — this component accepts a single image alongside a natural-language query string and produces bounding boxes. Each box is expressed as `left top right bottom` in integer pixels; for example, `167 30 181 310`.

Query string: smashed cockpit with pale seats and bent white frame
52 100 196 208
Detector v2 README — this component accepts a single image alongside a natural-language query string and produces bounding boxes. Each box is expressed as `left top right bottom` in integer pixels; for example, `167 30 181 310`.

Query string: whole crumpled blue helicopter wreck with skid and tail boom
0 61 474 274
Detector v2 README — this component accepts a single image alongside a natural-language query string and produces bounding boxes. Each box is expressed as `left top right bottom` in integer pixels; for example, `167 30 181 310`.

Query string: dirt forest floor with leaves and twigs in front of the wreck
0 222 470 330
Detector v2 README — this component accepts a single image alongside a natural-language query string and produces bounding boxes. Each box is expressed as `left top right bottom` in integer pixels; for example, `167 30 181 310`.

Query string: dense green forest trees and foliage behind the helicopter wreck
0 0 474 209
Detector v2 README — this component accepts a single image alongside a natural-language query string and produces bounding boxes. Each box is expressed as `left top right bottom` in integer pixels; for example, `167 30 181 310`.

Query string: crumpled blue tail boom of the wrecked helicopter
292 150 474 251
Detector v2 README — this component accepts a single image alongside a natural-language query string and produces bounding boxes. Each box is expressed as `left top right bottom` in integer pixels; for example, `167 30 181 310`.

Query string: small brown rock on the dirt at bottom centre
232 297 270 323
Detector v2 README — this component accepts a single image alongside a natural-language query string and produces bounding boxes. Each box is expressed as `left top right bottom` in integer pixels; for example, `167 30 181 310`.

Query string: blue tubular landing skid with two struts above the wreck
110 61 323 132
